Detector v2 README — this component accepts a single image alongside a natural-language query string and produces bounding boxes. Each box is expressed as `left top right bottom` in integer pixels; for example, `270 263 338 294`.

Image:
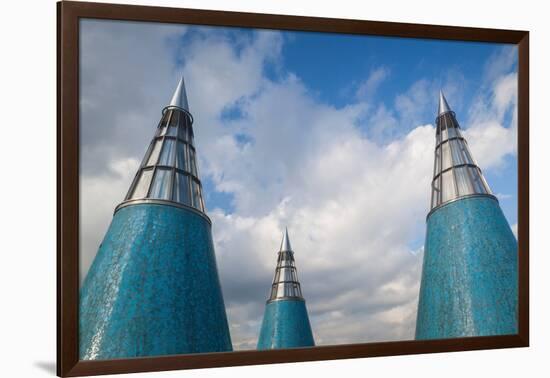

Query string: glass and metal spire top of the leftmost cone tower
121 76 206 213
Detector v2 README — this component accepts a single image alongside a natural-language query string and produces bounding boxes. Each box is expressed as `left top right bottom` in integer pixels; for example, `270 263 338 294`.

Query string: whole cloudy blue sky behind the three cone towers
80 20 517 349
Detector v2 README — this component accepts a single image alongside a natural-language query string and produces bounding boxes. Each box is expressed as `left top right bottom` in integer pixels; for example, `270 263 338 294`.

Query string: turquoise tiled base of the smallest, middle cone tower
258 299 315 349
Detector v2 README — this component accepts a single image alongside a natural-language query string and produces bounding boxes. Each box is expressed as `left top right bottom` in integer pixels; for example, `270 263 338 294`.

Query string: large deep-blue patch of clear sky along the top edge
283 32 490 106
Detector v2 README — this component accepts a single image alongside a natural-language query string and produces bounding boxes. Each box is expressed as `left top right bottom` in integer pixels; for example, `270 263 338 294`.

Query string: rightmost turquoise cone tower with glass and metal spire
416 93 518 339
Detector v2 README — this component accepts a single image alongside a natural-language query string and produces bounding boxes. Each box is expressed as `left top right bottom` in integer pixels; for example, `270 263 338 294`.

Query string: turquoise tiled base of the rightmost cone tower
416 197 518 339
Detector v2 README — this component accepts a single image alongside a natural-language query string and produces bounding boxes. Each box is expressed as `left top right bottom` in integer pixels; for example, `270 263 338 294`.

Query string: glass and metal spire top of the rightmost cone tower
430 91 492 213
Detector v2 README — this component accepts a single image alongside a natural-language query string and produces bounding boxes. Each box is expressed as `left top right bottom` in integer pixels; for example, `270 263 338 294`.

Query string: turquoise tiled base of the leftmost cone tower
79 204 232 360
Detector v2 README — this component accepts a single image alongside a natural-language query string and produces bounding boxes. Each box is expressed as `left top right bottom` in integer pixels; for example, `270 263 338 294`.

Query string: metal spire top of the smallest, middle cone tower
268 229 303 302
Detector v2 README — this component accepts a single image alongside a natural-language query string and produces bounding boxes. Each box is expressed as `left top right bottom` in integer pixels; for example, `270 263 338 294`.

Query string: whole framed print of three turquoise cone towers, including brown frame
57 1 529 376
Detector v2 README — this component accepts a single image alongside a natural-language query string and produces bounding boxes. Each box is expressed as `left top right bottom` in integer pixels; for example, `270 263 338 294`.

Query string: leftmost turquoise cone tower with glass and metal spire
79 77 232 360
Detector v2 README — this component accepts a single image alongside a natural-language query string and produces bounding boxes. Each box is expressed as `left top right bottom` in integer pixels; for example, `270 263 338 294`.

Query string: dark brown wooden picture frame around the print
57 1 529 376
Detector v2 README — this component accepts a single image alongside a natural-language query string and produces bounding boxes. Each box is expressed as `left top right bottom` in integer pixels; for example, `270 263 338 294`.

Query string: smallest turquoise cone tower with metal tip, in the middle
258 230 315 349
